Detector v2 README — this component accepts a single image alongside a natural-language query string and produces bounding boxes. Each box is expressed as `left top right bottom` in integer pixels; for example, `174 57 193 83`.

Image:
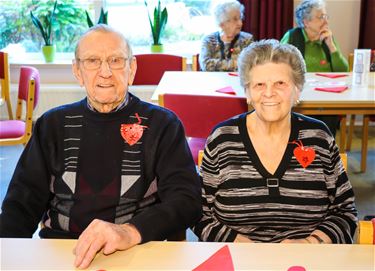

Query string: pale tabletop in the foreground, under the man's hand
0 239 375 271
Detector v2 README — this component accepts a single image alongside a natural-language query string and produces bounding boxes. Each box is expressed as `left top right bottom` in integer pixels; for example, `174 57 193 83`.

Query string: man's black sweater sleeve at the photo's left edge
0 120 50 238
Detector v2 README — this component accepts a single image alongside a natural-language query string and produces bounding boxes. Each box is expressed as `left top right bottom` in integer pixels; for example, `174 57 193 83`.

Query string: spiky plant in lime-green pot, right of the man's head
144 0 168 52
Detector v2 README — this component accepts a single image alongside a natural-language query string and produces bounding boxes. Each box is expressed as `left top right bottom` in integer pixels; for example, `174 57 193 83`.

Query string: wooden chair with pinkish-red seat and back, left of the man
0 67 40 146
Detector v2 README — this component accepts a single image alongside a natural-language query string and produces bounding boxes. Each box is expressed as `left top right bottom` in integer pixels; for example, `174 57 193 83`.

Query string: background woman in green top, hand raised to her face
281 0 349 136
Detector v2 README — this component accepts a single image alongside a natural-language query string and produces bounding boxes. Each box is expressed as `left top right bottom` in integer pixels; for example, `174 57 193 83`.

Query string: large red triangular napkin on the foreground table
193 245 234 271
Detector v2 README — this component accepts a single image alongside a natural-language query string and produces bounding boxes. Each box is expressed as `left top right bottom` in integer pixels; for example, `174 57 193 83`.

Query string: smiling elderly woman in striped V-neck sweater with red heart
193 40 357 244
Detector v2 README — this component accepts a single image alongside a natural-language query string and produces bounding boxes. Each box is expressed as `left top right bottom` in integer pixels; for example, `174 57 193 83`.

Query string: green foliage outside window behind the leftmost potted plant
0 0 87 52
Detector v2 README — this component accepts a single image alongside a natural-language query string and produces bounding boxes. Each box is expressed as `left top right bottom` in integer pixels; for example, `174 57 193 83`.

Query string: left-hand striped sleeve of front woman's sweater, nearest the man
193 138 237 242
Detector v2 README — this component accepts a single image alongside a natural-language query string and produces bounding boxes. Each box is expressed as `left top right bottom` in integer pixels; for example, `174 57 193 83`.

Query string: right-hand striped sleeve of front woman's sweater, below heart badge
317 140 358 243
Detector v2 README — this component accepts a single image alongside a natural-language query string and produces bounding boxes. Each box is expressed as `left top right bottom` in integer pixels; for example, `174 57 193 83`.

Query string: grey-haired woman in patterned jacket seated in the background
199 1 253 71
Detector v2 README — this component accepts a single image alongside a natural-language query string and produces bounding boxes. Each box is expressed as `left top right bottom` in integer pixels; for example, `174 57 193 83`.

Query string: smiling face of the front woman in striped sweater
246 62 300 123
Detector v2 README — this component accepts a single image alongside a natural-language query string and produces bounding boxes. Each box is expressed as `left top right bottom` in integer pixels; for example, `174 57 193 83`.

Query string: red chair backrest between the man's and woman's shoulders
159 93 248 138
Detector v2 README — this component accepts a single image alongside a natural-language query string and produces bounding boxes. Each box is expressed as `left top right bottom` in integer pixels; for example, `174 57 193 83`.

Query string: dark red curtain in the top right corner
358 0 375 50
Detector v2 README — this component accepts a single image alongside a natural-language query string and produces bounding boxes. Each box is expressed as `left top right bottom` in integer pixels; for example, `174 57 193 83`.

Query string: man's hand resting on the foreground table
73 219 141 269
